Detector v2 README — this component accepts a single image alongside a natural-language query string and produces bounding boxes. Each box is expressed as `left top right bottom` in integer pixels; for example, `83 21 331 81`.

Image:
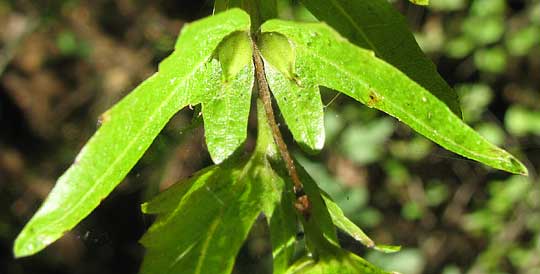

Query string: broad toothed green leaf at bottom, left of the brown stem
141 163 255 273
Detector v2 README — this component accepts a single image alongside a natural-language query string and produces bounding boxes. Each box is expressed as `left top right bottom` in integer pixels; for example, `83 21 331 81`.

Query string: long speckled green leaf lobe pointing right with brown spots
262 20 527 174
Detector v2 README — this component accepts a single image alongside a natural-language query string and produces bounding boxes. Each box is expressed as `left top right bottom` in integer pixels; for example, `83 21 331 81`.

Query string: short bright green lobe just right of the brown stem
259 33 325 152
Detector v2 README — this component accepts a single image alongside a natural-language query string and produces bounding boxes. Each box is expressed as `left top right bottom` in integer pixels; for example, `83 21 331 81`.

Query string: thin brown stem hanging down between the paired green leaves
253 42 311 219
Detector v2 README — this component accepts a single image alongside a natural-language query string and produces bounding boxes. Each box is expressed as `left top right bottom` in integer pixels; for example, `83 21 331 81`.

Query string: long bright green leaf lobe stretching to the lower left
14 10 249 257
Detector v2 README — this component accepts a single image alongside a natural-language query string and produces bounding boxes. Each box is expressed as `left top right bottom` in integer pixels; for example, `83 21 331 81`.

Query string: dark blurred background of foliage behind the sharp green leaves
0 0 540 274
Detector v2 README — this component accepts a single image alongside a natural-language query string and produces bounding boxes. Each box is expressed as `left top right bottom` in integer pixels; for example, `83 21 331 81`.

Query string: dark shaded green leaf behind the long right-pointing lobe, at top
301 0 461 117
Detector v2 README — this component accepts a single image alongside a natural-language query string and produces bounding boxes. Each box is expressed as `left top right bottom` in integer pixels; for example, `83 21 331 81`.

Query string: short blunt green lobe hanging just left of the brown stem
202 32 254 164
